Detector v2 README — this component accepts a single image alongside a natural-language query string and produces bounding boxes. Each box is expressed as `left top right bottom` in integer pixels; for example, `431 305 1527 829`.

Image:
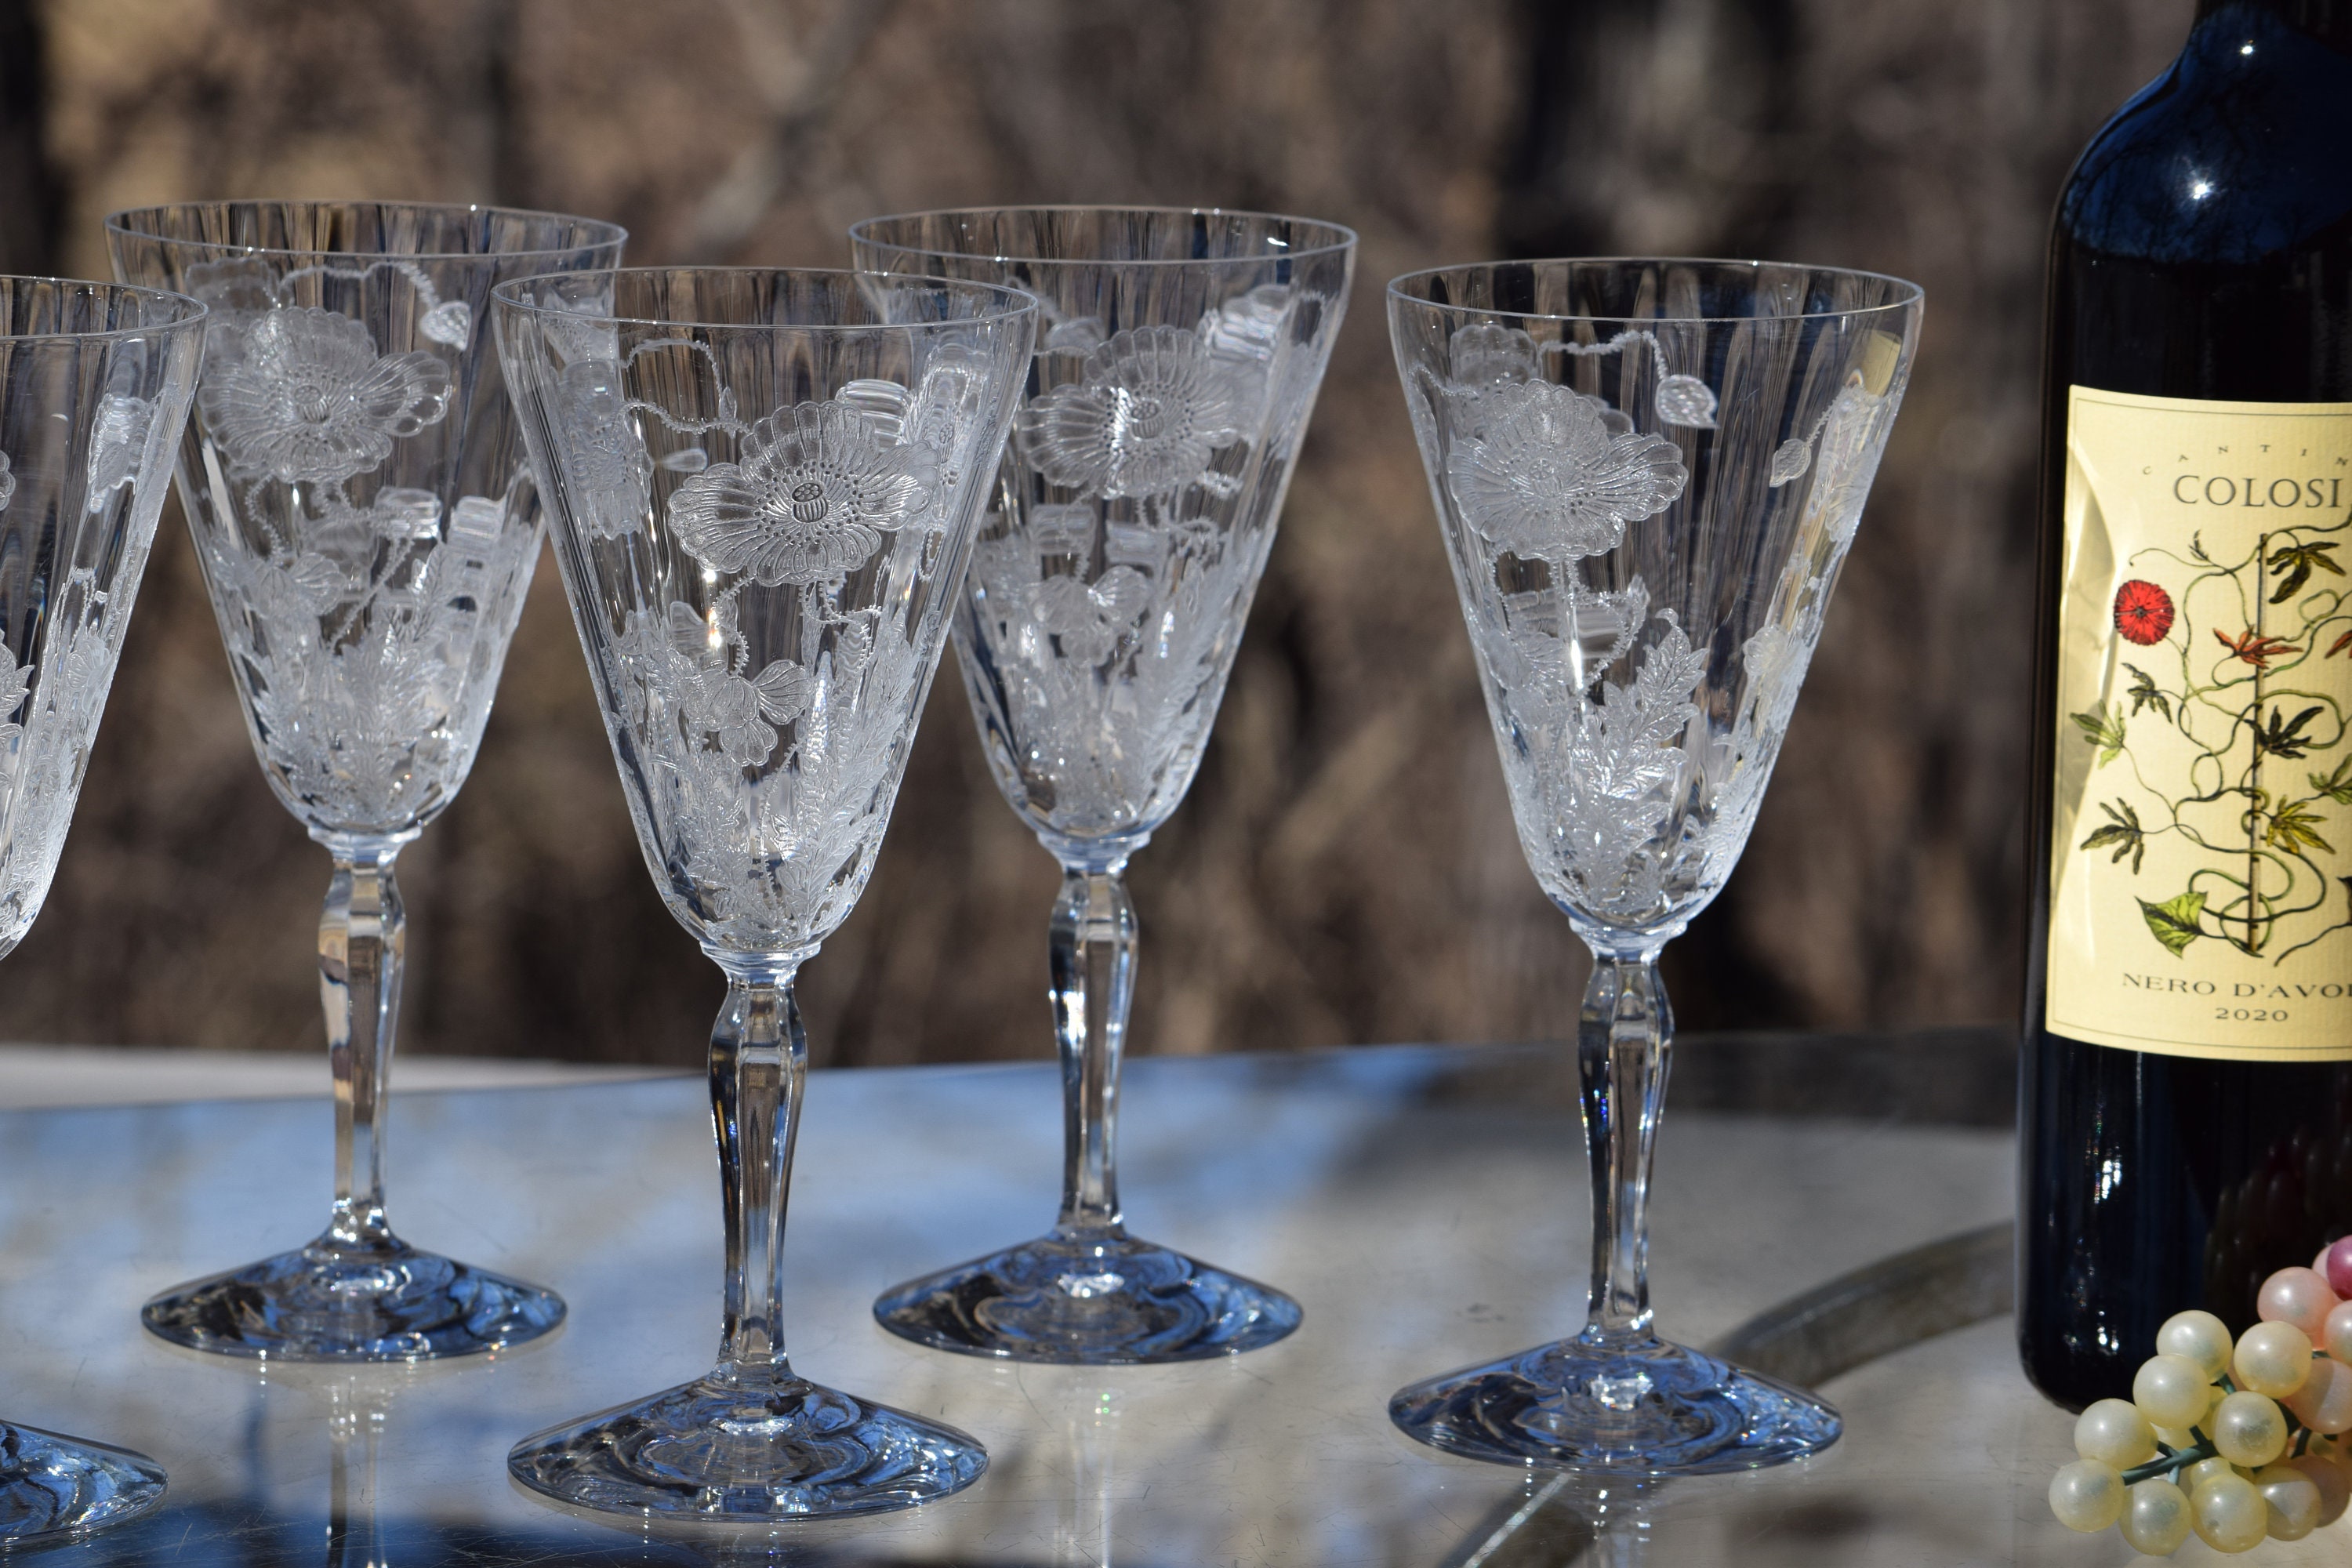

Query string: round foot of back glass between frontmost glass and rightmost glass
875 1229 1298 1366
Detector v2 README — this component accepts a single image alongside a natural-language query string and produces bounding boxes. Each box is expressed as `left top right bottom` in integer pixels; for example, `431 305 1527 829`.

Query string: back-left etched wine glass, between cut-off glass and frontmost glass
106 202 626 1361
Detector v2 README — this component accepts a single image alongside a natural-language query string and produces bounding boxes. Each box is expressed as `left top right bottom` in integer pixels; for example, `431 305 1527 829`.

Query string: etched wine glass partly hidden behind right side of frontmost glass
849 207 1355 1366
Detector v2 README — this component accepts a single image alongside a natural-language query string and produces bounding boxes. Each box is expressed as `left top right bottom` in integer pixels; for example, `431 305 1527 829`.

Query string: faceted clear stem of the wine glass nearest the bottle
1576 947 1675 1347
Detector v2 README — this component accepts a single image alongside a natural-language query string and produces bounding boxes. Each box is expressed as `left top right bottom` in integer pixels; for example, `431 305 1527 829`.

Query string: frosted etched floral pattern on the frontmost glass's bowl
520 329 1004 949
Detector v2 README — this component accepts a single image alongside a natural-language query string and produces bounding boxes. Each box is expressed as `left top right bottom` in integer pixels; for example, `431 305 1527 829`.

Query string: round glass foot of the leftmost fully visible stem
139 1236 564 1361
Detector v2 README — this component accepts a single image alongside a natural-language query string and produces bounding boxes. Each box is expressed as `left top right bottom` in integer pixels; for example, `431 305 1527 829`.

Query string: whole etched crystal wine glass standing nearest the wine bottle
1388 261 1922 1474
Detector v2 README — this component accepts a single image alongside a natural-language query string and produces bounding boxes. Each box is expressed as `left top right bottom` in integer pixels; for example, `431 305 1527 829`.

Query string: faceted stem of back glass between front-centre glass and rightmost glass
1051 858 1136 1236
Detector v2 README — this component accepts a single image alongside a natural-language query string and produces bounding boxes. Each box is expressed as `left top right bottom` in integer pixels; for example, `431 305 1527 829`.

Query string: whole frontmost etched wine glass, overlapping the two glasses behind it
496 268 1037 1519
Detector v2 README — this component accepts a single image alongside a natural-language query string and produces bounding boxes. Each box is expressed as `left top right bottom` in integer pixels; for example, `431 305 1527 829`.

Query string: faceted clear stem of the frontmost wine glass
710 954 809 1382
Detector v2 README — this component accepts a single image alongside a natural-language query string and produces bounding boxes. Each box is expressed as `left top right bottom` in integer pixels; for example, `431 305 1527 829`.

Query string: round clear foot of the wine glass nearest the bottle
1388 1340 1842 1476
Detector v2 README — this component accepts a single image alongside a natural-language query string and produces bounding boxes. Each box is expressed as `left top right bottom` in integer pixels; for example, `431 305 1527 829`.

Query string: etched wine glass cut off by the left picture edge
0 278 205 1552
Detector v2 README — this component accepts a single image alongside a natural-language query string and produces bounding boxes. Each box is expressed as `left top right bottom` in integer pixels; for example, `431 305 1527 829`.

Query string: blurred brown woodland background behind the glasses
0 0 2190 1062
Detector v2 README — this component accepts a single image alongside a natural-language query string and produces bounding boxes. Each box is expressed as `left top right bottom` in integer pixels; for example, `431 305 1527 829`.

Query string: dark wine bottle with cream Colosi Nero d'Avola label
2018 0 2352 1408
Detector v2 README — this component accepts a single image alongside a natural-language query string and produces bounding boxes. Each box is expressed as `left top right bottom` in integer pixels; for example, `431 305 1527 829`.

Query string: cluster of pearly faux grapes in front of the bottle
2051 1236 2352 1556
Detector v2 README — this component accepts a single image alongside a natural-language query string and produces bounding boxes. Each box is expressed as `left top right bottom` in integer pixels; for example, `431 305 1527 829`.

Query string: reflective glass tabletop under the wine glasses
0 1046 2164 1568
